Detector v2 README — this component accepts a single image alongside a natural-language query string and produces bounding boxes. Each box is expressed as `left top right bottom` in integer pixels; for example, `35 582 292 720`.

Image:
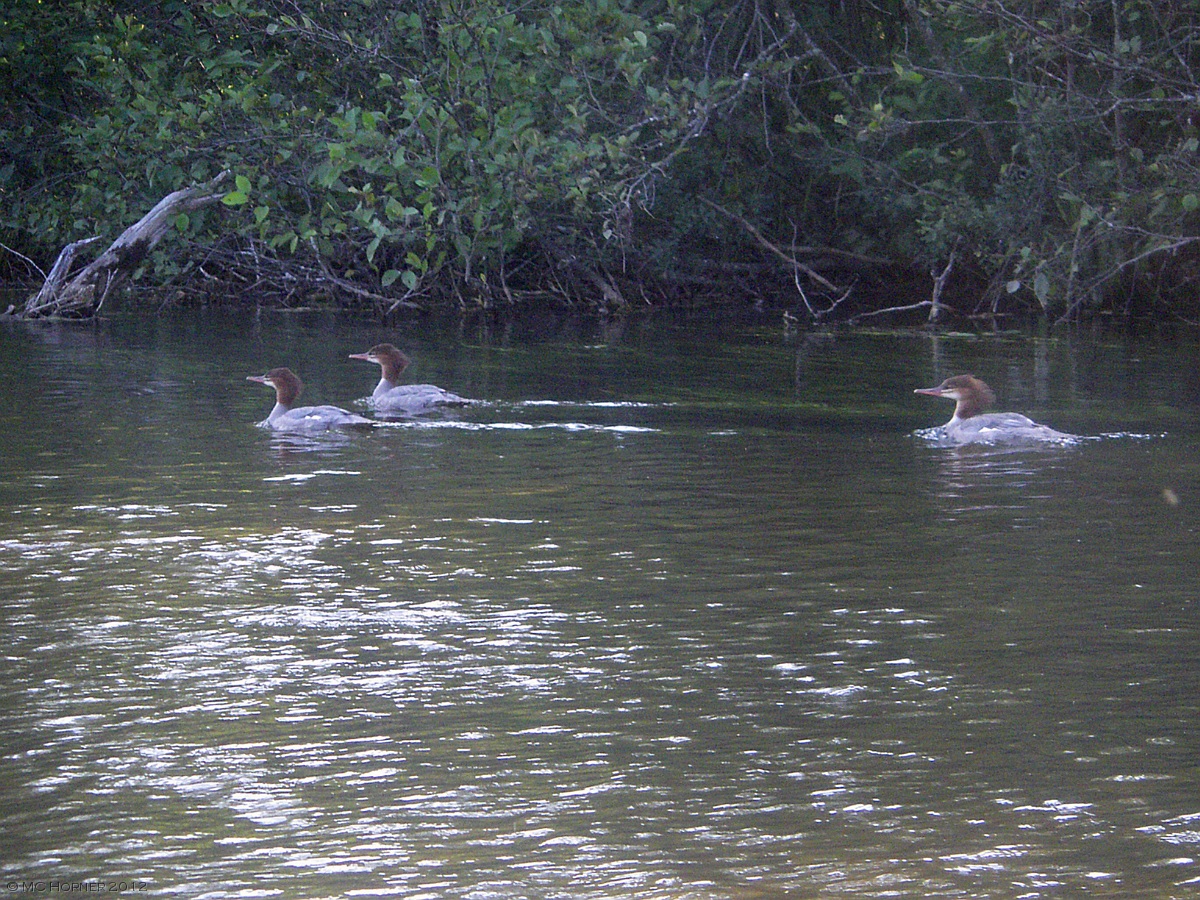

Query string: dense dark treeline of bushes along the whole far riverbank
0 0 1200 322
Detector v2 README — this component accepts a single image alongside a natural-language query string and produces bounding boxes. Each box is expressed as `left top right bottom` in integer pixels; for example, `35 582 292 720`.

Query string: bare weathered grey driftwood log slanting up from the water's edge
20 172 229 319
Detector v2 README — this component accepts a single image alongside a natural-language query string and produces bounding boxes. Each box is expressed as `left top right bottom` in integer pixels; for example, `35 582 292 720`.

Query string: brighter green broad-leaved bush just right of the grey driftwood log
264 0 705 303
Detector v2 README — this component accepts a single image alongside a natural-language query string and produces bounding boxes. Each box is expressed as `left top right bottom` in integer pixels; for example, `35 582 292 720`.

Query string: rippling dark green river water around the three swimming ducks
0 313 1200 900
